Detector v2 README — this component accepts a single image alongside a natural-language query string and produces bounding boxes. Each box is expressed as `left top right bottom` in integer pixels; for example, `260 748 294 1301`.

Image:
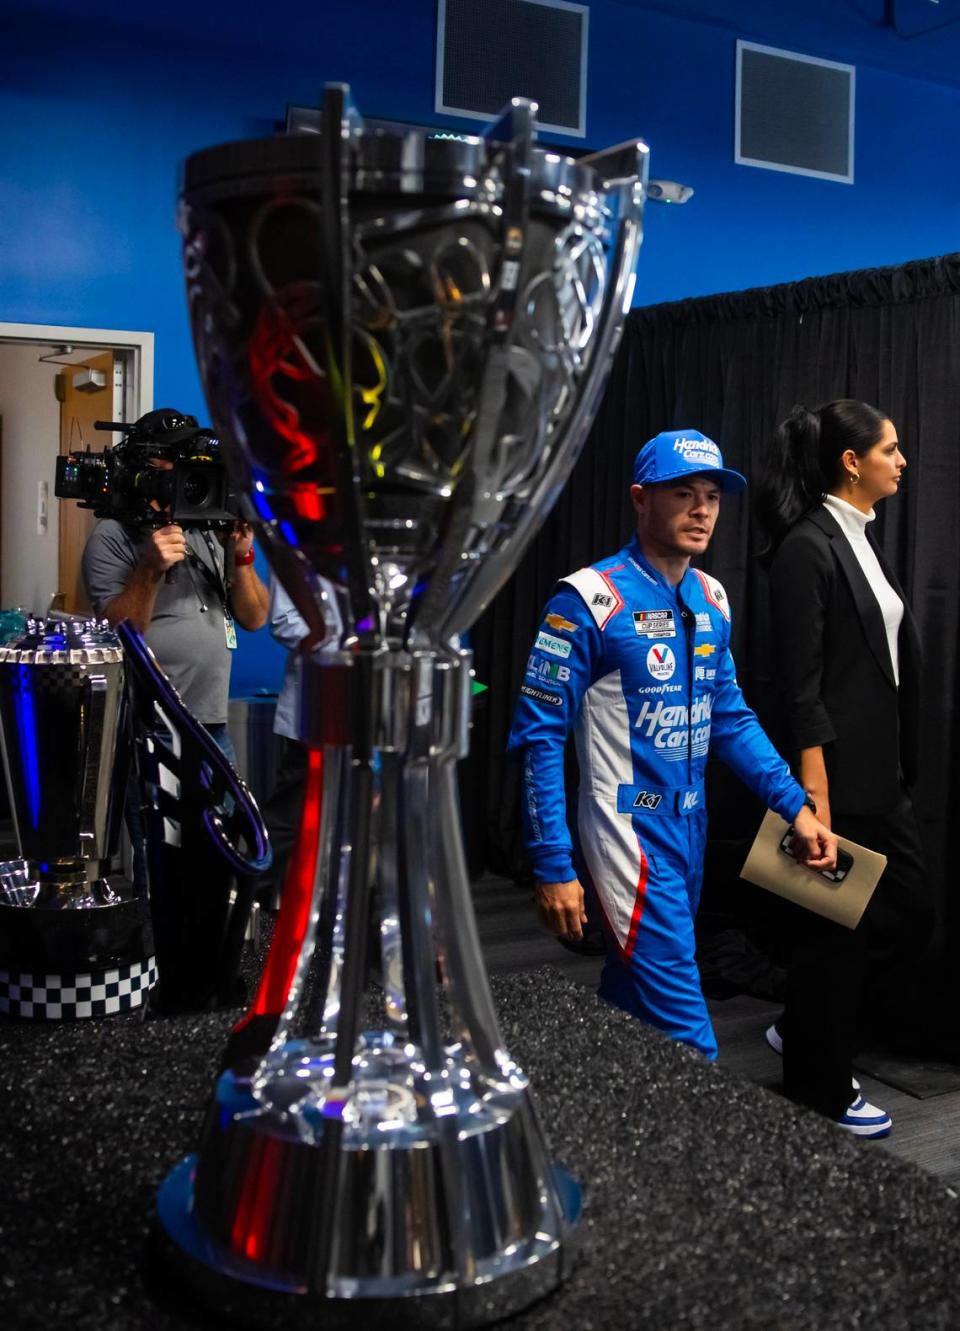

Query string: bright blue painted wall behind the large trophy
0 0 960 692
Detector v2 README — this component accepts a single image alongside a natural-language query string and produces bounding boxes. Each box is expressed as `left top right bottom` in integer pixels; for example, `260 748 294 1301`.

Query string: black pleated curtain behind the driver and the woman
466 254 960 947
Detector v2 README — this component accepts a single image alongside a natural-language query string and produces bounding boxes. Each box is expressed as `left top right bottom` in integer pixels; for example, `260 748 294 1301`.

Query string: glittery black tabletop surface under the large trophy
0 947 960 1331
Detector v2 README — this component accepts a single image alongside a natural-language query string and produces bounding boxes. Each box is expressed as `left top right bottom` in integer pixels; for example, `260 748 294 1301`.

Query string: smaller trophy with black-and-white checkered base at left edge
0 616 156 1018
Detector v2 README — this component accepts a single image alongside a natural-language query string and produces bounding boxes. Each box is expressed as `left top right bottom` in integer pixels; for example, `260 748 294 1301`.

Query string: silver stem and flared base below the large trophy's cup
160 652 578 1328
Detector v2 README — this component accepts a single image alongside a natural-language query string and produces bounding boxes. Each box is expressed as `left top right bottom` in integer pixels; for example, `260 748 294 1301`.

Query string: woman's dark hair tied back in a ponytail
754 398 887 559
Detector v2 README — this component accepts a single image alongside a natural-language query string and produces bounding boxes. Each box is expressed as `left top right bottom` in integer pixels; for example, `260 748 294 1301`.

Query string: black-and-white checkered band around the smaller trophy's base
0 957 157 1021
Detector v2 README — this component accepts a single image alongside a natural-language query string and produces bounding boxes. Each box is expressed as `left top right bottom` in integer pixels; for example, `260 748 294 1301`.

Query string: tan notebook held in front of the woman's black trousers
740 809 887 929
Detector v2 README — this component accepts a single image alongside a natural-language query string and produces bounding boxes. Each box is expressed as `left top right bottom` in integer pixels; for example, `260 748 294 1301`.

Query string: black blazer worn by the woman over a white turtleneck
770 507 920 815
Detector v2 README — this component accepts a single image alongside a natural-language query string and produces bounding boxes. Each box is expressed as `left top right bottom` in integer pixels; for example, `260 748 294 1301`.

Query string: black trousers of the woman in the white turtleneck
778 793 935 1118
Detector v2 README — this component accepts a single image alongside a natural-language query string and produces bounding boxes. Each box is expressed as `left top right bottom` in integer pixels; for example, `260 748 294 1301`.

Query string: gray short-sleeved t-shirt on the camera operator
81 518 230 725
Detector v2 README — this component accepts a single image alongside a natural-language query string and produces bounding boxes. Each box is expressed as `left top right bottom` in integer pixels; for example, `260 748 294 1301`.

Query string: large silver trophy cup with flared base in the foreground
158 87 647 1327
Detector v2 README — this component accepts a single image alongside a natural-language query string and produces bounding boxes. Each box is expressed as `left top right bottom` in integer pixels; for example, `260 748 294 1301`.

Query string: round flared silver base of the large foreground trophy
157 1033 581 1331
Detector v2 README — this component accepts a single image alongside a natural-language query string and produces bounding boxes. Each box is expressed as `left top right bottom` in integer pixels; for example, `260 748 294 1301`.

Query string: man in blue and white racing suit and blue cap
509 430 836 1058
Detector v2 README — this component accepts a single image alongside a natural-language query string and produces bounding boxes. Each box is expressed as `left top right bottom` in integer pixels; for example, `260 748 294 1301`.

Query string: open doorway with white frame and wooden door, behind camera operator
0 322 153 615
